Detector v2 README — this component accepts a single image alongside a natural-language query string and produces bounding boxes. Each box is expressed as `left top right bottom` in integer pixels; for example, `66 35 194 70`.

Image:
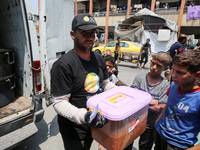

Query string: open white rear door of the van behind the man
40 0 74 105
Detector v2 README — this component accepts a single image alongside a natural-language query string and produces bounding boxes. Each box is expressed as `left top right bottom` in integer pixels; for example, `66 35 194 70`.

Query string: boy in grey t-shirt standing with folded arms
131 52 172 150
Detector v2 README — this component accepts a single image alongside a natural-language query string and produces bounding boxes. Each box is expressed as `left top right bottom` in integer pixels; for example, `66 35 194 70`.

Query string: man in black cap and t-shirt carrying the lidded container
51 13 115 150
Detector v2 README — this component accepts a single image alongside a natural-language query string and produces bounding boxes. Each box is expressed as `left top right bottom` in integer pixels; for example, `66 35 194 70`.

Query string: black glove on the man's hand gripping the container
85 111 108 128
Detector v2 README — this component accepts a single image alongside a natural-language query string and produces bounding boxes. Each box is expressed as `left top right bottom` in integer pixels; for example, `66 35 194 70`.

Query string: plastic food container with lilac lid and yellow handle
87 86 152 150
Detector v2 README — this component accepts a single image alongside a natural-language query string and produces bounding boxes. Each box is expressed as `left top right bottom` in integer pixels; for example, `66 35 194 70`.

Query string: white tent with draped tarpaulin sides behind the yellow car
115 8 178 53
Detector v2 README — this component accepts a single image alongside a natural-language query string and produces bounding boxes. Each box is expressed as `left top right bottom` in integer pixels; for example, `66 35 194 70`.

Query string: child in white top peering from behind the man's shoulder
104 55 117 84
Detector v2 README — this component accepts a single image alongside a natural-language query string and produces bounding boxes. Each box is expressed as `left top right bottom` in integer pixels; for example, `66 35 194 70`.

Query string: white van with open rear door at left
0 0 74 149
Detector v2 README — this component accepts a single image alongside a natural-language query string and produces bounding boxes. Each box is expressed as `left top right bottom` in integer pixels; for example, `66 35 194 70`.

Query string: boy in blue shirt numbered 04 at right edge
155 50 200 150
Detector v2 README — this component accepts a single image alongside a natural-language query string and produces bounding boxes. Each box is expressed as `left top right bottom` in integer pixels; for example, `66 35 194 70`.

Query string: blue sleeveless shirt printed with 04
155 82 200 149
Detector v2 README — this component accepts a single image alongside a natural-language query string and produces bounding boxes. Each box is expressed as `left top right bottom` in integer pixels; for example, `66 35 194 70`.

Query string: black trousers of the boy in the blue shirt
154 131 184 150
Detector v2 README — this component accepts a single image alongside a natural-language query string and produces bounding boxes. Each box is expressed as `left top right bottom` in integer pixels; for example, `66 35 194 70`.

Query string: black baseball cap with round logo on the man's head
72 13 103 30
